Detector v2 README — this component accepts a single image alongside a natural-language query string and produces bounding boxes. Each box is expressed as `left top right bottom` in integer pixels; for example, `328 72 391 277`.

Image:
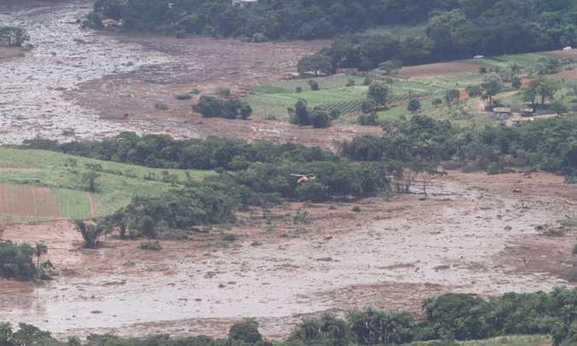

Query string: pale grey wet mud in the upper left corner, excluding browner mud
0 0 166 143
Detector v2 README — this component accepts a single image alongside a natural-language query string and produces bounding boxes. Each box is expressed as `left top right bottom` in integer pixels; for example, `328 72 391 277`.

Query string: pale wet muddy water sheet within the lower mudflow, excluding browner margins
0 173 570 335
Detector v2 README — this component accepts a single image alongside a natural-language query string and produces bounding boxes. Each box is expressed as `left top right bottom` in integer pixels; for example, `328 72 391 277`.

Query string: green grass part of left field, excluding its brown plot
0 147 215 219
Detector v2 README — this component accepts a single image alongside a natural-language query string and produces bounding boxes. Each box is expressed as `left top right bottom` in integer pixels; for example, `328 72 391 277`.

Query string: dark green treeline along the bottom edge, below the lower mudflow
5 288 577 346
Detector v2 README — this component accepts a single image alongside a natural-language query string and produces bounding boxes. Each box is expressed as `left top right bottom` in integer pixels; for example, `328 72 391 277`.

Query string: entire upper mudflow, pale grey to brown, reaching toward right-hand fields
0 0 381 148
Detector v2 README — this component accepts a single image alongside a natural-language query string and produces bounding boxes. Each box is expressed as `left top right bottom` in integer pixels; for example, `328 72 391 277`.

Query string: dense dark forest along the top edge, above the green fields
89 0 577 69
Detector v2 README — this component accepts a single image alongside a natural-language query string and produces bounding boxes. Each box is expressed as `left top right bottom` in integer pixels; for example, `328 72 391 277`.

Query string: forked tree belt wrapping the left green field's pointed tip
24 133 397 238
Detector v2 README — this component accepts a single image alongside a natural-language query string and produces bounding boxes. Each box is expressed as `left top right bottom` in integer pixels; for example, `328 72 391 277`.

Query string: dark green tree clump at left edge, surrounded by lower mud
0 240 36 280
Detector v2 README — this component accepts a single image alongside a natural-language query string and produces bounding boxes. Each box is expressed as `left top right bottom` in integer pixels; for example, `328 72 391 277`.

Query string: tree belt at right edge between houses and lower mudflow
342 115 577 176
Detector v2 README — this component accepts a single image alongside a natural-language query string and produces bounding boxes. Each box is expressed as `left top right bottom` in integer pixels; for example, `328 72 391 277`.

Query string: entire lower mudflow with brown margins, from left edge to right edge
0 172 577 337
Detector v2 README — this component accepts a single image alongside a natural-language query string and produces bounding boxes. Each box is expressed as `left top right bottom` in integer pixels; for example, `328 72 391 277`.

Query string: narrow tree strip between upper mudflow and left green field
24 132 339 171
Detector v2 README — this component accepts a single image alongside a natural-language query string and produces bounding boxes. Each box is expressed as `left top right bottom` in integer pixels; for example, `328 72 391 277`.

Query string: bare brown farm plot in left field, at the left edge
0 184 59 218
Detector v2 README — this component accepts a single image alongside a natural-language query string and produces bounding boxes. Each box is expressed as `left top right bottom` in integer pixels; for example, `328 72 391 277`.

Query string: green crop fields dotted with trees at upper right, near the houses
248 50 577 126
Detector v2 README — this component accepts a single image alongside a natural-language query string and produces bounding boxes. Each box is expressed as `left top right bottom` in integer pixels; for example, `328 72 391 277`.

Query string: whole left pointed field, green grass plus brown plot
0 147 215 220
